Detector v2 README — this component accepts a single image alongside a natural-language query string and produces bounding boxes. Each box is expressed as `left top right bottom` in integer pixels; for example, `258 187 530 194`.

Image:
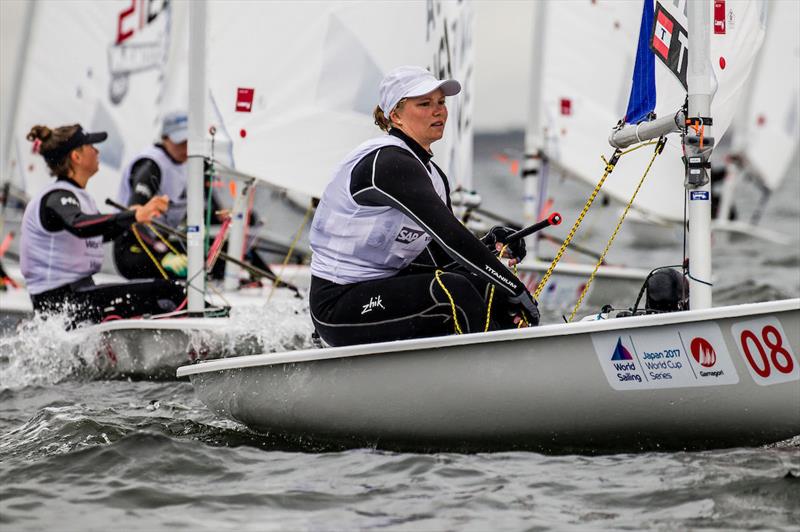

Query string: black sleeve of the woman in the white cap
350 147 525 295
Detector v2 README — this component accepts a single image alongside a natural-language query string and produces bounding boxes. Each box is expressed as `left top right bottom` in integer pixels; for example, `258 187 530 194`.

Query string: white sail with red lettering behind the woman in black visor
8 0 171 209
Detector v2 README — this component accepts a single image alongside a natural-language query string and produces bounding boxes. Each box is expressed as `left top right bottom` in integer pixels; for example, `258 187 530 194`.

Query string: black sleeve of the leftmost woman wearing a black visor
39 190 136 242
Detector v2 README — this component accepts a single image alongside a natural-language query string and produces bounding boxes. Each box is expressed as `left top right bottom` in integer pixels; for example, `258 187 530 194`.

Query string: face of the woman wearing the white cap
392 89 447 150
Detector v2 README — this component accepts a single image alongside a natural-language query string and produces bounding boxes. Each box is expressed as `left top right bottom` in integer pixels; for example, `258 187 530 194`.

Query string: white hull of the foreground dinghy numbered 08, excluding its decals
178 300 800 452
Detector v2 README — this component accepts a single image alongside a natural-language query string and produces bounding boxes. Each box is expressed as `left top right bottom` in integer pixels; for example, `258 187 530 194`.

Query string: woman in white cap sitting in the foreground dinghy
309 66 539 345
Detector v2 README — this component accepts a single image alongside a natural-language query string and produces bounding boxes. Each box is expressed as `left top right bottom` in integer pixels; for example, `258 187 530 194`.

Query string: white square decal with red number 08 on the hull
731 316 800 386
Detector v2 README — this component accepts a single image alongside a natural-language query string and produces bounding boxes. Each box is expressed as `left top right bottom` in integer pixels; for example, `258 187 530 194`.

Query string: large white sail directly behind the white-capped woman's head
203 1 473 196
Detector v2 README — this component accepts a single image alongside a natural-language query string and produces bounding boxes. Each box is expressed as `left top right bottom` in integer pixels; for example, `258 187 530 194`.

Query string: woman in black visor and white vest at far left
20 124 182 322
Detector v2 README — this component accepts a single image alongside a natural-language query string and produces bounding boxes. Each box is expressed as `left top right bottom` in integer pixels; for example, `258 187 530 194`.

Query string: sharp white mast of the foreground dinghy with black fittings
684 0 716 310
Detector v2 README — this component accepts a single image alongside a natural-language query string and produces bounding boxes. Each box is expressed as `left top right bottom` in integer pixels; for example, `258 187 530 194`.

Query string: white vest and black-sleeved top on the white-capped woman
311 129 525 296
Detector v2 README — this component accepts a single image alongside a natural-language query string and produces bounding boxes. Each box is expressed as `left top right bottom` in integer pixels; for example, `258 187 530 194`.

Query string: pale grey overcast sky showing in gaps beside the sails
0 0 533 131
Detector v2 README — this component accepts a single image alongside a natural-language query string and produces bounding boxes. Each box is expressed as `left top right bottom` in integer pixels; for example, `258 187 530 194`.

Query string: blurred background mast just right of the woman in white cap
522 1 548 255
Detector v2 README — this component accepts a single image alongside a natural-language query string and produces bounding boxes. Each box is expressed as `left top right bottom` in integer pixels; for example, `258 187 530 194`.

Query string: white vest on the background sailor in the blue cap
117 146 186 227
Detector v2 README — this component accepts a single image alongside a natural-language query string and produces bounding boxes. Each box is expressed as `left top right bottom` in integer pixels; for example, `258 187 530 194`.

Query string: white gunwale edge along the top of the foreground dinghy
176 298 800 377
